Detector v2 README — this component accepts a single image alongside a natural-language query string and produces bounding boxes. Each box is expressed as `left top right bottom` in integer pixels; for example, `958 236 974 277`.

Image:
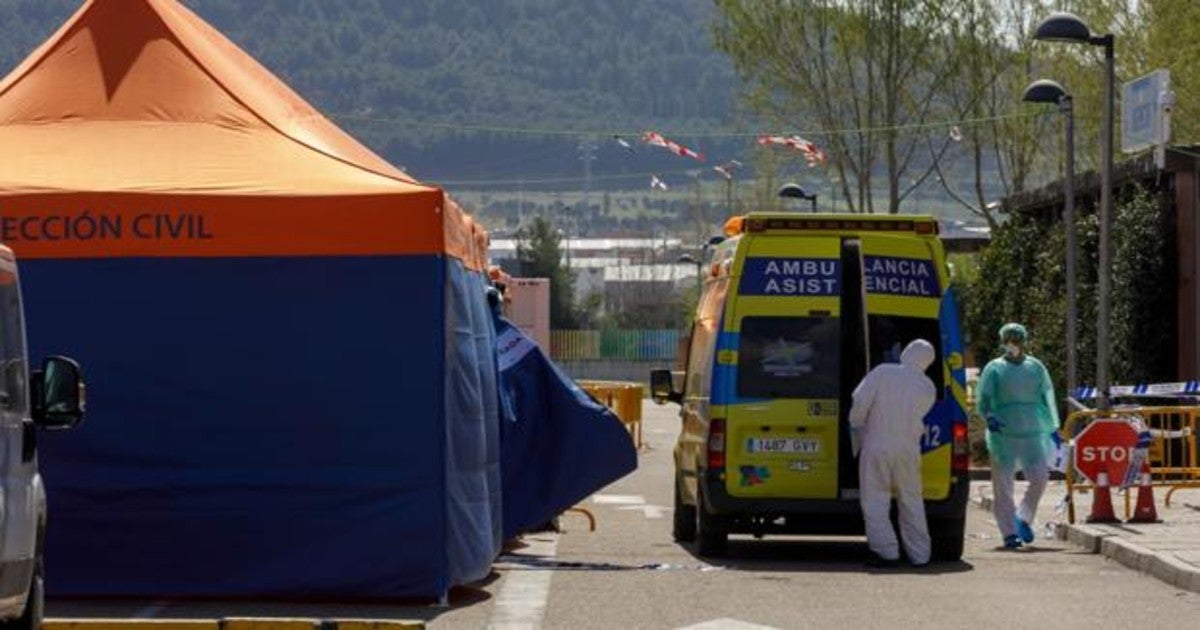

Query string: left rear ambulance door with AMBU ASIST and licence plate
725 234 844 499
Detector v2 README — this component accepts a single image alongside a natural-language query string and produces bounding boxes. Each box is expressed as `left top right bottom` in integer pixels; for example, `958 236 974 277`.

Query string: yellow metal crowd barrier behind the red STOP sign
1062 406 1200 523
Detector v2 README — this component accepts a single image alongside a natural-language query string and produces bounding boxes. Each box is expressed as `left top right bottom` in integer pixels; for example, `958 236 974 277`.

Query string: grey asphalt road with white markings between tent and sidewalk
47 404 1200 630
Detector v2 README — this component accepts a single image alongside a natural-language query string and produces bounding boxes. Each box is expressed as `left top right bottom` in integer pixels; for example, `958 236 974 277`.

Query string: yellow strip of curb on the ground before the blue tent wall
42 617 425 630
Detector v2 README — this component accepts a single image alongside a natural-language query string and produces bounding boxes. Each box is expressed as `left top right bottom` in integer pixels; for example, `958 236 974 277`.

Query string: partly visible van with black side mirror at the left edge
0 245 84 629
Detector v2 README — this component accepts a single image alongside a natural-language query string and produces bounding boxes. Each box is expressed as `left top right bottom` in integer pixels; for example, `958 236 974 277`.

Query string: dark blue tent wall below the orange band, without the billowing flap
22 256 499 598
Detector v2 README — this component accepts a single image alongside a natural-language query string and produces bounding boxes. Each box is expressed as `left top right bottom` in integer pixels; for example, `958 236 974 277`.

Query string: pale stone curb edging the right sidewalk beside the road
971 487 1200 593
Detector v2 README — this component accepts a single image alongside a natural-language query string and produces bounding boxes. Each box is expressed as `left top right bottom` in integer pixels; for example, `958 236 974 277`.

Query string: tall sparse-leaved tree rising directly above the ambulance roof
716 0 980 214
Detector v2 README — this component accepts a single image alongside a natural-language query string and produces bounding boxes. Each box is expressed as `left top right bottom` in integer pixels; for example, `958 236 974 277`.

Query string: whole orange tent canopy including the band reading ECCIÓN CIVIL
0 0 486 269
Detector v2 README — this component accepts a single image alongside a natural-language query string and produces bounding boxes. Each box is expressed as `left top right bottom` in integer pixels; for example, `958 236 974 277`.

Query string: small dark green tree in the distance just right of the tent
517 217 578 329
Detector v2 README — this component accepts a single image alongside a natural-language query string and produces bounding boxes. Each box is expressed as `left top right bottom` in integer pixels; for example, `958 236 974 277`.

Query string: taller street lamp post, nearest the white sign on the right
1033 12 1116 410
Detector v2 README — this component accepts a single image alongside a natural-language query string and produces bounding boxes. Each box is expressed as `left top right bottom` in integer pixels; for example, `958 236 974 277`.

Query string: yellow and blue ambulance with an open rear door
650 214 970 560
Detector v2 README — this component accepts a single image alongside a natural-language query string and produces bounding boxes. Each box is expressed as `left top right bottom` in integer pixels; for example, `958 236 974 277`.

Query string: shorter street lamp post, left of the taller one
1021 79 1079 396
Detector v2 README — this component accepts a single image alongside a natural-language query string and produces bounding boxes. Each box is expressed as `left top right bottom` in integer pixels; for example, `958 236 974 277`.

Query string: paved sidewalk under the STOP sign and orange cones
971 481 1200 593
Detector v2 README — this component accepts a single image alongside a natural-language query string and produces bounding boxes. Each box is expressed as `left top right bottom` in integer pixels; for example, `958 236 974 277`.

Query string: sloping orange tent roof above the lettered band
0 0 432 196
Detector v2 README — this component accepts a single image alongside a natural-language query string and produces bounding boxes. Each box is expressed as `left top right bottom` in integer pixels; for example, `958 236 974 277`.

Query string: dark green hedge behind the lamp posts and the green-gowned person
965 187 1178 391
